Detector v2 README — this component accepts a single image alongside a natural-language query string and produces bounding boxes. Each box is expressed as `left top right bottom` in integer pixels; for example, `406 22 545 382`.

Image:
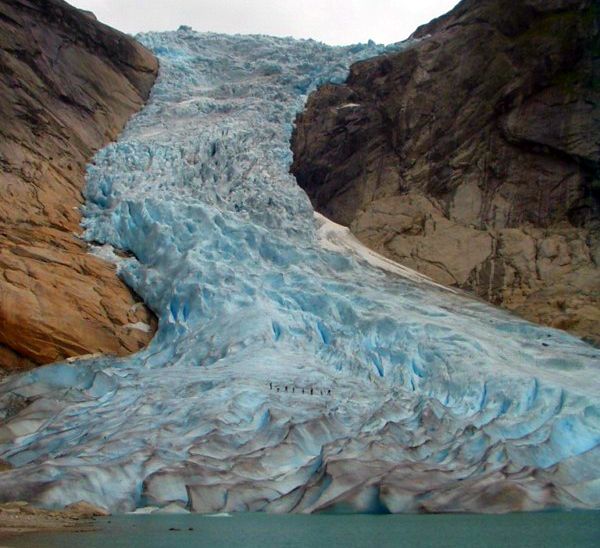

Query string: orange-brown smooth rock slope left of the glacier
0 0 158 371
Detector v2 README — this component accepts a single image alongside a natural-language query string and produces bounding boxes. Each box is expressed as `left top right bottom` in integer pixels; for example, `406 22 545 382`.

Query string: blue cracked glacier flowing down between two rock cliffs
0 30 600 512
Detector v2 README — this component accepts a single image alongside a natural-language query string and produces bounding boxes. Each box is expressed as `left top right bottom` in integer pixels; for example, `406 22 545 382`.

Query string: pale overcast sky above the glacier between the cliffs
68 0 458 44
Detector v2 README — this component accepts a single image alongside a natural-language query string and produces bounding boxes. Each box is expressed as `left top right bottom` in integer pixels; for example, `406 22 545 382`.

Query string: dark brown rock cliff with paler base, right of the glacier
292 0 600 343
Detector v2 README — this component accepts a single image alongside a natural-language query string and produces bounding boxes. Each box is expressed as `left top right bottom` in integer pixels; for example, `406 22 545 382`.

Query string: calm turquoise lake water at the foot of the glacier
5 512 600 548
